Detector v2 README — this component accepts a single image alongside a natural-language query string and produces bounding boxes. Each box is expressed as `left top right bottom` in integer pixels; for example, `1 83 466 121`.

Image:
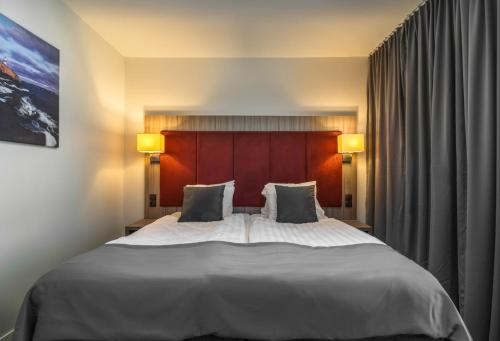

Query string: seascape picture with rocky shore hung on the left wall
0 14 59 148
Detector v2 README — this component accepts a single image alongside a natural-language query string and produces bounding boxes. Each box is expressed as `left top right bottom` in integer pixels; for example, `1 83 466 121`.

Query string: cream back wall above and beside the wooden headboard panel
124 58 368 223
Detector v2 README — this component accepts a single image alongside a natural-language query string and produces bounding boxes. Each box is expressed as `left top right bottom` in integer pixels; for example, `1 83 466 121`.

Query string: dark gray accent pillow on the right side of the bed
274 185 318 224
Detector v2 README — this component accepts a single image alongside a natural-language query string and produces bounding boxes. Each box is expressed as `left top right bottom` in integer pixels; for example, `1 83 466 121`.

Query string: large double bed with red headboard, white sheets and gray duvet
14 132 471 341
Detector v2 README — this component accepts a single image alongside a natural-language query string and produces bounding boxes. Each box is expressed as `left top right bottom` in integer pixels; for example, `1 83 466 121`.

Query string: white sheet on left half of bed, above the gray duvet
107 214 248 245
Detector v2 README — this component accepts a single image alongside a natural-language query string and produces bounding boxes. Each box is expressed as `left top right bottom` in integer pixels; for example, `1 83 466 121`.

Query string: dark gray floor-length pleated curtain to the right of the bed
367 0 500 341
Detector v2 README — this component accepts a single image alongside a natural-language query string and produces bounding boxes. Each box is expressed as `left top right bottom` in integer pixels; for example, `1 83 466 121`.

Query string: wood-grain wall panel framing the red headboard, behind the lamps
144 113 357 219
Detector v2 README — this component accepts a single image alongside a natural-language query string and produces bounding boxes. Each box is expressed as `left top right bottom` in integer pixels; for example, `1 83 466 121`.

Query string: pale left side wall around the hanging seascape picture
0 0 125 337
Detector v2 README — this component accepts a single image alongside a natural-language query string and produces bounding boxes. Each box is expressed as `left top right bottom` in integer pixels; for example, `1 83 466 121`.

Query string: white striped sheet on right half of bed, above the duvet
249 215 384 247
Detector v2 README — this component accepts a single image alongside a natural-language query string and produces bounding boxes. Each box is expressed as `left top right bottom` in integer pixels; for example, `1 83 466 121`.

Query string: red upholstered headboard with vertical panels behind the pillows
160 131 342 207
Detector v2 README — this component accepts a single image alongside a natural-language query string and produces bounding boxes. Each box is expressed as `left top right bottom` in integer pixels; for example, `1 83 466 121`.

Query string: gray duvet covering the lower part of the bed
14 242 470 341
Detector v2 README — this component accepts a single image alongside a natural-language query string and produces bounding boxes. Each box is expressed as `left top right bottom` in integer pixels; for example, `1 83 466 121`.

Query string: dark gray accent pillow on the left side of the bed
178 185 226 223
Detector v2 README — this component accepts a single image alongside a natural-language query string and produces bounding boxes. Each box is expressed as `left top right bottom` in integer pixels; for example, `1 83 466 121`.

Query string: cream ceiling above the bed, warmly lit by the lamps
64 0 421 58
